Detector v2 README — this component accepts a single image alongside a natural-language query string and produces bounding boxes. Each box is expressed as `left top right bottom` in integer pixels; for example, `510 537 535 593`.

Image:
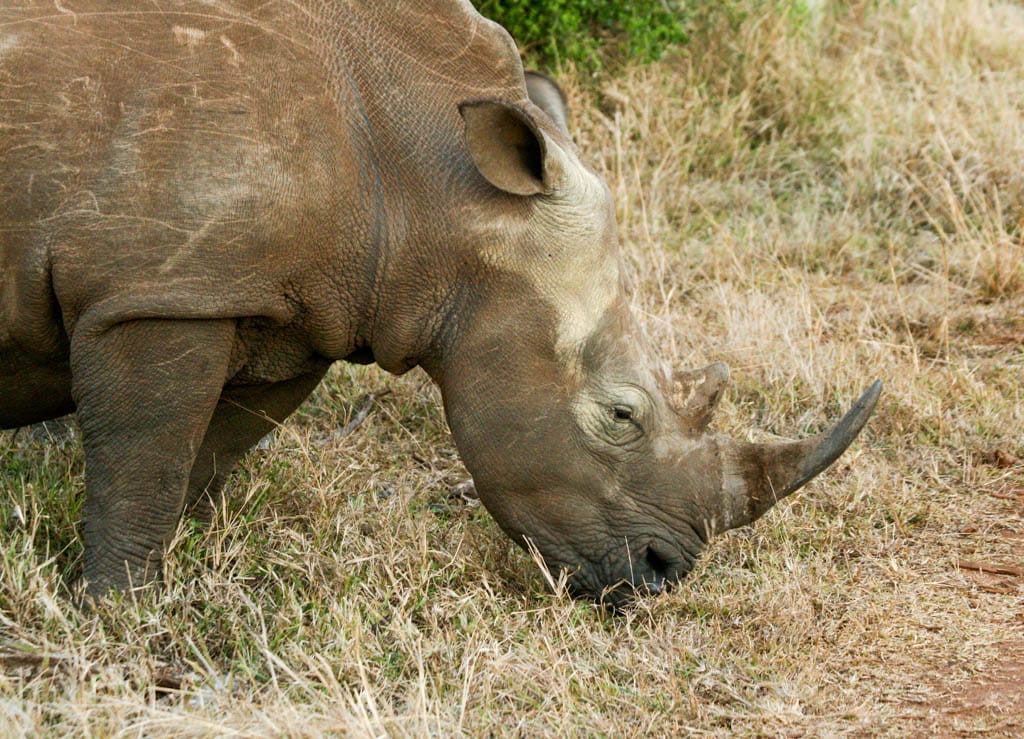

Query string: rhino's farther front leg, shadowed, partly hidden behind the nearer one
186 362 330 520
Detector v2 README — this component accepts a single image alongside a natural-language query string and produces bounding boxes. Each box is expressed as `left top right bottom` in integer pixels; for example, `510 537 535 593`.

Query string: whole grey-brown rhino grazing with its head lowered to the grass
0 0 879 604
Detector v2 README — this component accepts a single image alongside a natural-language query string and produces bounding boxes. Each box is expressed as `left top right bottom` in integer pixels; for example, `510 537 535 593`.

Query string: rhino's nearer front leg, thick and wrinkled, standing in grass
71 320 234 596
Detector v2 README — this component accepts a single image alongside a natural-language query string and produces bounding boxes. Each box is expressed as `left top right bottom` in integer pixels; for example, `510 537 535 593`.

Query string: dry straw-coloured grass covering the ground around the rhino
0 0 1024 736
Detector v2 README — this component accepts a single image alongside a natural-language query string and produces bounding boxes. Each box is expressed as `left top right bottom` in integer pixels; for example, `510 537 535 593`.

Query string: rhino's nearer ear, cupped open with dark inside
459 100 551 195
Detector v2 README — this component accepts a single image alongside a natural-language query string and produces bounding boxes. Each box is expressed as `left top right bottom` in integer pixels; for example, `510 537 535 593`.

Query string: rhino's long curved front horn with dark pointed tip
719 380 882 528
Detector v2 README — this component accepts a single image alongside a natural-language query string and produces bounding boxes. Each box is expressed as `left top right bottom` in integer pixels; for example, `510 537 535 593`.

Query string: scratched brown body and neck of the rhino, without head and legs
0 0 522 368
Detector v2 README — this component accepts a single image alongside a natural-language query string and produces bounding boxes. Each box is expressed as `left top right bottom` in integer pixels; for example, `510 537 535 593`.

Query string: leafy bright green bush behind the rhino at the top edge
476 0 686 71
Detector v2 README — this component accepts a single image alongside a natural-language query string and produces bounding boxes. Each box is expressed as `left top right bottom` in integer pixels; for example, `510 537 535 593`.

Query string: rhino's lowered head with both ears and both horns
432 76 881 606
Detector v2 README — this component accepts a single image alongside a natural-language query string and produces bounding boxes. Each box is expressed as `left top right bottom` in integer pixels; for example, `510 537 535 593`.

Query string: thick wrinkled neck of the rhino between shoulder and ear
299 0 523 377
